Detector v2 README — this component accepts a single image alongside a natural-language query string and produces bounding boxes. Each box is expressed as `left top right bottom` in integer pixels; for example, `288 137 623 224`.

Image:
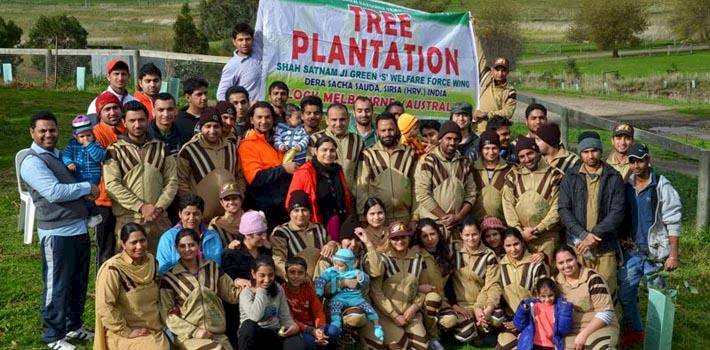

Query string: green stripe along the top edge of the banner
281 0 469 26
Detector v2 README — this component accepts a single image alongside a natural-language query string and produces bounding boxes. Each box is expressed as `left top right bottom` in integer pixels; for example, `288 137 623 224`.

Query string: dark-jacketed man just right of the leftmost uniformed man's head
144 92 192 156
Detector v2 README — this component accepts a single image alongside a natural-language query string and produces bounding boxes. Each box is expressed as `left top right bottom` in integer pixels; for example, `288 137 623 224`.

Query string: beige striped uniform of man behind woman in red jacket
307 129 365 188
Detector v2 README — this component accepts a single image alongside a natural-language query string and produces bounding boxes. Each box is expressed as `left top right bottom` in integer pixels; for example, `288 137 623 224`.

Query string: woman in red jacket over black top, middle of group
286 135 352 242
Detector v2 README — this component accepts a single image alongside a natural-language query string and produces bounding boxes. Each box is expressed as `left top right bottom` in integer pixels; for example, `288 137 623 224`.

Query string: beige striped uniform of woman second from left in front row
160 260 240 350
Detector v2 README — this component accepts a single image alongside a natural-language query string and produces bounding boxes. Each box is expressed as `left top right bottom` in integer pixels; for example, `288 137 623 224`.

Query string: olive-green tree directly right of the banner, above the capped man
474 0 523 69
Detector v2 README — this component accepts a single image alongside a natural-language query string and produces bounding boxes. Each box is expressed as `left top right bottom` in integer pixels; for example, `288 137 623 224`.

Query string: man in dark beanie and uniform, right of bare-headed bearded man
414 121 477 240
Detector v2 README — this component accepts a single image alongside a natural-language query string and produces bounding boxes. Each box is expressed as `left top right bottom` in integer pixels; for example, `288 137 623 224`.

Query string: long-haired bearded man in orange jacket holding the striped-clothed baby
239 101 296 227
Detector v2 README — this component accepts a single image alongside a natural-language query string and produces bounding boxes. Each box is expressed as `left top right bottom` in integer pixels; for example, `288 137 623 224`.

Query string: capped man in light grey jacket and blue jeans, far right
619 143 682 344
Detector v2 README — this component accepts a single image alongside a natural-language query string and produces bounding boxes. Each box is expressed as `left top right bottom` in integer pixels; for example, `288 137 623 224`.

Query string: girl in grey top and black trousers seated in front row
238 257 305 350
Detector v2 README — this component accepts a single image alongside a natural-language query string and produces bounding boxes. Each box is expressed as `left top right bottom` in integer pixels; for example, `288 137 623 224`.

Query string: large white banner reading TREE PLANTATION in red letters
256 0 478 118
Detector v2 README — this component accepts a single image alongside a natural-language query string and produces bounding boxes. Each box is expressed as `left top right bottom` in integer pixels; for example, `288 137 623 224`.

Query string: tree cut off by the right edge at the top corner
669 0 710 43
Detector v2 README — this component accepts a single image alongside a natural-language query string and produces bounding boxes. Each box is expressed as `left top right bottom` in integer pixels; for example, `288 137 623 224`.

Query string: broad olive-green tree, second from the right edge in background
568 0 648 57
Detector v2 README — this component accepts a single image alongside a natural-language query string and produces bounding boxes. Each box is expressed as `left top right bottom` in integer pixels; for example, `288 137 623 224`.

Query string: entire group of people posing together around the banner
20 24 681 350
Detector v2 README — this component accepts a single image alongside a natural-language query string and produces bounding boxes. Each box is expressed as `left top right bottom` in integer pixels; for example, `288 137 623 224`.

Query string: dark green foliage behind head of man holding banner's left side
198 0 259 40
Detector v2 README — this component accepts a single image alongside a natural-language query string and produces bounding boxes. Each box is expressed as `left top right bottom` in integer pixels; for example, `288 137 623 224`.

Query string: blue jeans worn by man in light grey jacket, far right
618 251 665 332
